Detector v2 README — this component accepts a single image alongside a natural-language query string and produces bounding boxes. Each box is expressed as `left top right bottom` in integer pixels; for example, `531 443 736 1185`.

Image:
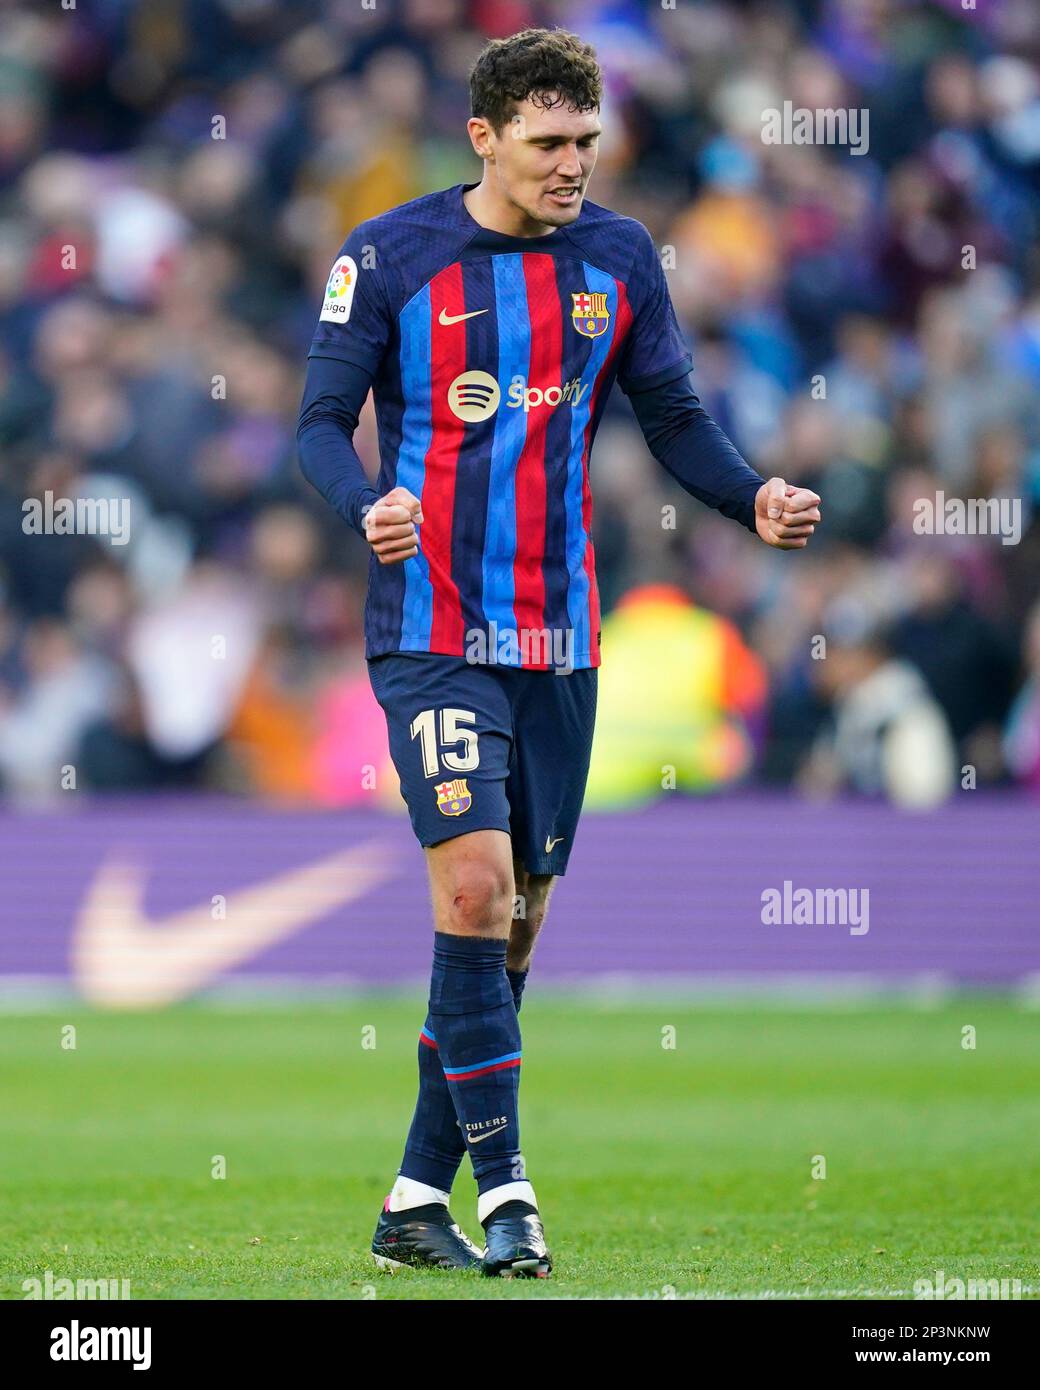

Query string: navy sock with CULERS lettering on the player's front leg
430 931 524 1193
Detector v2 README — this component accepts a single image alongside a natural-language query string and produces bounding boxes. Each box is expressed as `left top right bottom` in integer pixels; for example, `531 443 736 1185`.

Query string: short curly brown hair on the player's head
470 29 603 135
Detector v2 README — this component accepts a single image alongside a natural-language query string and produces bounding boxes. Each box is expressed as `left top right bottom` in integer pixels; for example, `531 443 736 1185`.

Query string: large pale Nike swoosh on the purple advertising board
70 840 392 1009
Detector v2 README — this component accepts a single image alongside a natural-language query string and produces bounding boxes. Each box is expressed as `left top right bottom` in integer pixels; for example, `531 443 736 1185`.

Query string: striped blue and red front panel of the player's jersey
395 252 631 669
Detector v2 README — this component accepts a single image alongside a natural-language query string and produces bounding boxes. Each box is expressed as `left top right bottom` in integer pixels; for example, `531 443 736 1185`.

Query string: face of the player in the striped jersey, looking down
489 99 601 227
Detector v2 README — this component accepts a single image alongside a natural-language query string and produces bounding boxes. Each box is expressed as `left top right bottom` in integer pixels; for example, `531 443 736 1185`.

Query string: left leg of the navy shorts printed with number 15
368 653 512 849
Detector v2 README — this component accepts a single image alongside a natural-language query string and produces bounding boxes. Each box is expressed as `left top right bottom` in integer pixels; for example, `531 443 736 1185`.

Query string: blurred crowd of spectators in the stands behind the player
0 0 1040 805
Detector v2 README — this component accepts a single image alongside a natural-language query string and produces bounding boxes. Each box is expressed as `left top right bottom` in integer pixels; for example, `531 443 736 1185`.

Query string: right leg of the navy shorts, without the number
507 669 598 878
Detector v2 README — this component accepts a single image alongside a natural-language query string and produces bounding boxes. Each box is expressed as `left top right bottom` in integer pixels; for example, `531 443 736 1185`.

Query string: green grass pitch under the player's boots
0 1000 1040 1300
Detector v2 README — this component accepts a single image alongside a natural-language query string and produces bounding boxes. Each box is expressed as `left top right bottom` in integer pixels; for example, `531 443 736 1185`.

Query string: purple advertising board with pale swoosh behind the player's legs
0 794 1040 1008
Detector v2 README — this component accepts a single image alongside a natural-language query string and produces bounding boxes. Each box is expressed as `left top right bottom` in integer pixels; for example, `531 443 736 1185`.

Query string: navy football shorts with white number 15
368 652 598 874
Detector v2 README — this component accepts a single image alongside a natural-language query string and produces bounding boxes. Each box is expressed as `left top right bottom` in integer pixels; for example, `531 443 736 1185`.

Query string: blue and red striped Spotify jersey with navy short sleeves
310 183 691 670
